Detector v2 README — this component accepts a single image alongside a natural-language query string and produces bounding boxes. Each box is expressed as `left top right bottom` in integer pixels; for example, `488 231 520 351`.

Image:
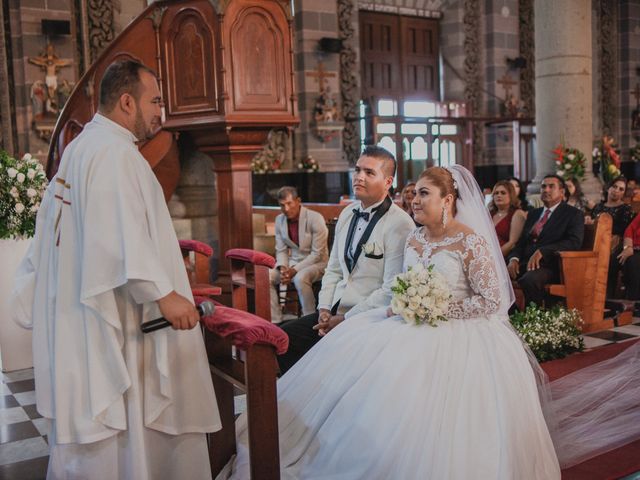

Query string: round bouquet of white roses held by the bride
391 263 451 327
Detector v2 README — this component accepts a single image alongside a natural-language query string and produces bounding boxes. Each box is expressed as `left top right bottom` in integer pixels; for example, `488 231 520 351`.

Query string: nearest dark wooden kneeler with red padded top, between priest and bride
198 299 289 480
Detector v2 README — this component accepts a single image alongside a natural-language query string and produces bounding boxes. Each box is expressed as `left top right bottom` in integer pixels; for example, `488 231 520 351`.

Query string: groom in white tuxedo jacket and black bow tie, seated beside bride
278 146 415 373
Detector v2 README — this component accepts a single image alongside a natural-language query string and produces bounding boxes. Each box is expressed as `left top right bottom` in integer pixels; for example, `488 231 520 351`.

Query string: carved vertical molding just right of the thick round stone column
596 0 618 135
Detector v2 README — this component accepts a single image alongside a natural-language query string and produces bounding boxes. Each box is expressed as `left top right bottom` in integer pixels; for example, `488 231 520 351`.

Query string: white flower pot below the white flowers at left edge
0 238 33 372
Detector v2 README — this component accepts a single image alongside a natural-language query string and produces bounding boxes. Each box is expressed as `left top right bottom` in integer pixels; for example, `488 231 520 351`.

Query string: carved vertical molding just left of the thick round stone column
518 0 536 117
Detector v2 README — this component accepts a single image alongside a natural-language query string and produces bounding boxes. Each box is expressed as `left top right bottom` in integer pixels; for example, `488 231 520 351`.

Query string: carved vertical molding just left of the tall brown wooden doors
338 0 360 165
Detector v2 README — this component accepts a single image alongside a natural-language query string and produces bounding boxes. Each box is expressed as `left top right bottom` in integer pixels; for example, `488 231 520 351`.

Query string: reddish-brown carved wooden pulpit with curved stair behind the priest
46 0 298 284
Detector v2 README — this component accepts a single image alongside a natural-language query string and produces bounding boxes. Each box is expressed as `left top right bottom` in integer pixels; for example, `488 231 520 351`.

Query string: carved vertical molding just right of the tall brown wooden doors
462 0 482 158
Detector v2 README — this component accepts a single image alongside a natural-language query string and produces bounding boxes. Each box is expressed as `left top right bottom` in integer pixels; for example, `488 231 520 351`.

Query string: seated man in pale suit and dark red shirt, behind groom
270 187 329 323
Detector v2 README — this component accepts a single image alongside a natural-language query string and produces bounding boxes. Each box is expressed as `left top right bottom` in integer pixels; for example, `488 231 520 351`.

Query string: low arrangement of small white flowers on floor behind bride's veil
510 303 584 362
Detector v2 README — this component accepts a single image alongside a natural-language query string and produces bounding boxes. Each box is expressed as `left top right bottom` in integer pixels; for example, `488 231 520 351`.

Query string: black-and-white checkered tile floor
0 318 640 480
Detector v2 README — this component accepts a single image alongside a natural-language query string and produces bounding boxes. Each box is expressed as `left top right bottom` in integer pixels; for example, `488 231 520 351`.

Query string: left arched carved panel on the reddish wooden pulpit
165 8 218 115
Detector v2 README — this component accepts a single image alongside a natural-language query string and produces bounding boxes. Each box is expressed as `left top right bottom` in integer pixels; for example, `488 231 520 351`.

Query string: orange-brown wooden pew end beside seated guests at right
547 214 613 333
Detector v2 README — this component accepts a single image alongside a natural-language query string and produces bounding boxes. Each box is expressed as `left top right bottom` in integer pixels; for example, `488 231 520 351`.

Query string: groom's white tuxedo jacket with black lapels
318 197 415 318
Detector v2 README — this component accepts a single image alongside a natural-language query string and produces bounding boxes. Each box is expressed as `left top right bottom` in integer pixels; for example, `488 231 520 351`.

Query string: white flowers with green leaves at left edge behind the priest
0 150 47 239
